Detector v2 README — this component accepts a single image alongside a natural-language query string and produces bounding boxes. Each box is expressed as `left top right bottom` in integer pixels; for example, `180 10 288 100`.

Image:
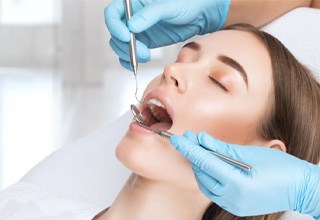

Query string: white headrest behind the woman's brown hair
262 8 320 80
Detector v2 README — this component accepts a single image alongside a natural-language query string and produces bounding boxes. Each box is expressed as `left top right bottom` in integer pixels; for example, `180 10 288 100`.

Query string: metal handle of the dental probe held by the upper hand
124 0 138 76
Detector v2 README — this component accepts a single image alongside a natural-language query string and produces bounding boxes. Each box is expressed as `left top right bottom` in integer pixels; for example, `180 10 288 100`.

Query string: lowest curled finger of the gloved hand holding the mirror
192 165 222 196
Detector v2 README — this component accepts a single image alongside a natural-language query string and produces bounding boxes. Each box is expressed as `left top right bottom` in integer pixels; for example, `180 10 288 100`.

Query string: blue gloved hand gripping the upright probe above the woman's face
105 0 230 70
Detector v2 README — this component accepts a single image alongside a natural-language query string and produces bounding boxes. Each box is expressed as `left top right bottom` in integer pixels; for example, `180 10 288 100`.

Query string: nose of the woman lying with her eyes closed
162 63 191 93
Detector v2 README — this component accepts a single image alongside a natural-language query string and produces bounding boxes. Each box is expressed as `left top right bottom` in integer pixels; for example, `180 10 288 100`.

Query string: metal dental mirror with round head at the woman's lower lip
131 105 252 170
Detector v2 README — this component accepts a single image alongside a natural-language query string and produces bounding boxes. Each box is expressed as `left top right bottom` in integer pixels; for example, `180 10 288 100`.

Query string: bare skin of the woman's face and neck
99 30 283 220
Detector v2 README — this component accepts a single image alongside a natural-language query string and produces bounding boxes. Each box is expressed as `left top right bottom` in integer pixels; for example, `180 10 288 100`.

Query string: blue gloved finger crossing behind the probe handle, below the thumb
110 37 151 63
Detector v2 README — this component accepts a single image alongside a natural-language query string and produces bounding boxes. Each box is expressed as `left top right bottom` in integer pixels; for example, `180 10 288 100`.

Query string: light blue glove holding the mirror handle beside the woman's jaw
170 132 320 219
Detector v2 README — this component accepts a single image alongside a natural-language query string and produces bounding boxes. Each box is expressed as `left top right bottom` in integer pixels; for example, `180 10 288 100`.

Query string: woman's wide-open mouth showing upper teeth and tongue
142 98 172 131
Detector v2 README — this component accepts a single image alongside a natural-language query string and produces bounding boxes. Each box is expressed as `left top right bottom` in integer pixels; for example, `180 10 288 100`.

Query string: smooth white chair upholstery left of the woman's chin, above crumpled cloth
21 112 132 206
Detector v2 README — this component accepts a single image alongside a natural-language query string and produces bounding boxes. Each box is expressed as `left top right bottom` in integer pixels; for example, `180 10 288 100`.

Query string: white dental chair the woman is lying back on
0 8 320 220
